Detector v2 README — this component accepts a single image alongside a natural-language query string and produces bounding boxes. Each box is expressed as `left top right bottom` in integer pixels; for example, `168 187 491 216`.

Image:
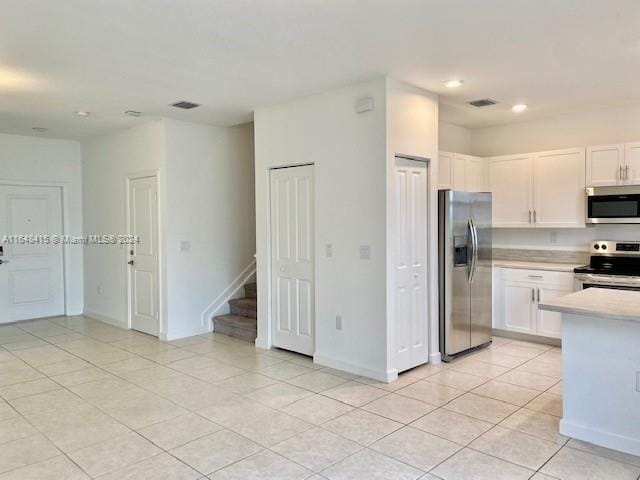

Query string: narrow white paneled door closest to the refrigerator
394 158 428 372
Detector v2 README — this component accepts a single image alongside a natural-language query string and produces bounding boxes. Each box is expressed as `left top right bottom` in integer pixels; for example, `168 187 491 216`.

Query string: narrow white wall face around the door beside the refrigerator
387 79 440 368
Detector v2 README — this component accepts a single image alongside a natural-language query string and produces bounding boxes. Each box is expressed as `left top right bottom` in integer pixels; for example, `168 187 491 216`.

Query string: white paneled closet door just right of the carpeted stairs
271 165 315 355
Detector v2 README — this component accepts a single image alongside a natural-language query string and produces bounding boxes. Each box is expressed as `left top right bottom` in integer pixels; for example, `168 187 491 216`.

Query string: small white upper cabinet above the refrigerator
438 152 487 192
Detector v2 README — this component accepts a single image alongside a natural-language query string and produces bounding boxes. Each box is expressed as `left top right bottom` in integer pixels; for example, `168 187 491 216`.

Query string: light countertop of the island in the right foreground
538 288 640 322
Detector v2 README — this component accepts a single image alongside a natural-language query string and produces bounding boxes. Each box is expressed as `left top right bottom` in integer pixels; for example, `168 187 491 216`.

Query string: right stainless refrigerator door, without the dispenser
470 193 492 347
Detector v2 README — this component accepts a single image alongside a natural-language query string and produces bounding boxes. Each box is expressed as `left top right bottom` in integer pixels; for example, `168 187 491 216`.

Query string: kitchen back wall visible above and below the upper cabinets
471 105 640 250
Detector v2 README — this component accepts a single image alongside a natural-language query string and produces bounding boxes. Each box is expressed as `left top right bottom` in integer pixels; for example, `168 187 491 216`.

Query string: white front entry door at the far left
0 185 65 323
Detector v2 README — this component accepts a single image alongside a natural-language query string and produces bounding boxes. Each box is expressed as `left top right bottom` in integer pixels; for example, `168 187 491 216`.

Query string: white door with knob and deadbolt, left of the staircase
127 177 160 336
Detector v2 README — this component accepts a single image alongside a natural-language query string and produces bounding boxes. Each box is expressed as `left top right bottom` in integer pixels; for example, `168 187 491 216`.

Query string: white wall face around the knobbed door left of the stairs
82 120 166 331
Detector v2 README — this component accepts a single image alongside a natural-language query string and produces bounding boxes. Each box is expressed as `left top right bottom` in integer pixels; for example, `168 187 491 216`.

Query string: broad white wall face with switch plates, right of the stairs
254 78 387 378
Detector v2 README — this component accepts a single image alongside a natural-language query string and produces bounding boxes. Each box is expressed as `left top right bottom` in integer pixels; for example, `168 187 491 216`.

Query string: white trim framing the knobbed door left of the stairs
123 170 161 338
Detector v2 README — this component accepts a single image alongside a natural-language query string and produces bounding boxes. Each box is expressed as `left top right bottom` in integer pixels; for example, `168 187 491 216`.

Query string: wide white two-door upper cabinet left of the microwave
489 148 585 228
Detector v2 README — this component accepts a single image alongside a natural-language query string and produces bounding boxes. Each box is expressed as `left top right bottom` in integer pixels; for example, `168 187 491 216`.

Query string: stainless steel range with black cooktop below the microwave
574 240 640 291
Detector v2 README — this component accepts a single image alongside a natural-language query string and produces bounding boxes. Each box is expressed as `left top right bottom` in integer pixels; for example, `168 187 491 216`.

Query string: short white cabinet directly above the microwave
587 142 640 187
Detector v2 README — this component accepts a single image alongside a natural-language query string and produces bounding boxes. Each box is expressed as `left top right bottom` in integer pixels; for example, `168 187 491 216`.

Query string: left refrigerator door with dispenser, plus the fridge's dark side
439 190 472 358
